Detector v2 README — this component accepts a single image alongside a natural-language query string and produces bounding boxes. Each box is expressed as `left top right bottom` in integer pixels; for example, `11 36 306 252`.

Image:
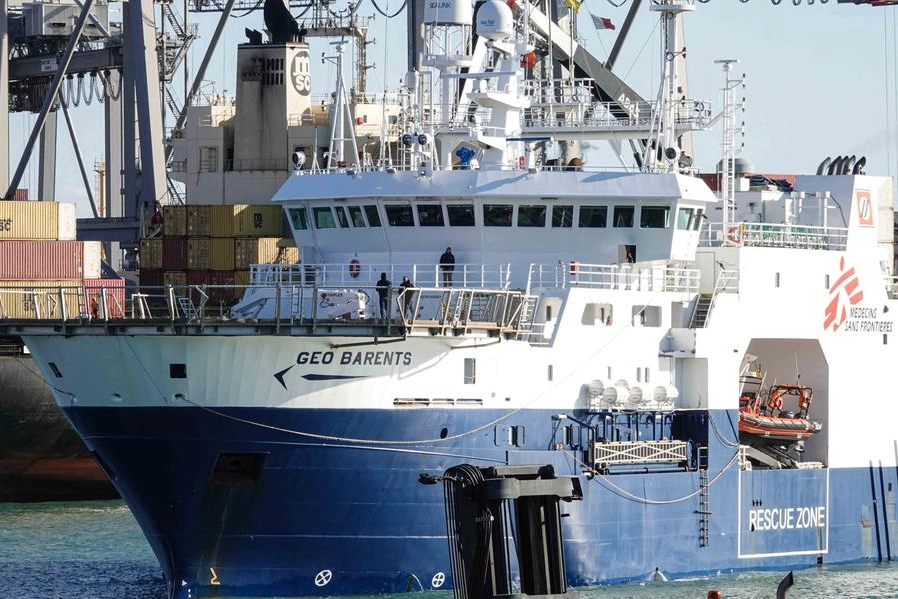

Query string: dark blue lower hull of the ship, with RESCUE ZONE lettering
65 407 898 597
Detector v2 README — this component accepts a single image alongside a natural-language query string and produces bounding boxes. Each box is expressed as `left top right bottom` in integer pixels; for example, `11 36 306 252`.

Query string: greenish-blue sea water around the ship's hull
0 501 898 599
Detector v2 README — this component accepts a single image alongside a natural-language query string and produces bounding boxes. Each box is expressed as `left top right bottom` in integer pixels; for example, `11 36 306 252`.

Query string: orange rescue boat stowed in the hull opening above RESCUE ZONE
739 385 823 445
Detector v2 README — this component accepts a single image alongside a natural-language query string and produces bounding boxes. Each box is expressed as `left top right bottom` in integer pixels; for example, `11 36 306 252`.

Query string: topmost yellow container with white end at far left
0 200 75 241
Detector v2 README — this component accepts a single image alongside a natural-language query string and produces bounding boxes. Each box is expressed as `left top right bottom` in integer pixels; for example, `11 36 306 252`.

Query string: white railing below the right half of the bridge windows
527 261 701 293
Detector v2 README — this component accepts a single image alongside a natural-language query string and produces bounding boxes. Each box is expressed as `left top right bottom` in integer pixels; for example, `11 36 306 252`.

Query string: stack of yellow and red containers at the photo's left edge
0 200 125 318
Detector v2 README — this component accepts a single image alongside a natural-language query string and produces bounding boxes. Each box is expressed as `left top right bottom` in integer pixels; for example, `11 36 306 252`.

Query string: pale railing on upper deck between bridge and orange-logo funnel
700 222 848 251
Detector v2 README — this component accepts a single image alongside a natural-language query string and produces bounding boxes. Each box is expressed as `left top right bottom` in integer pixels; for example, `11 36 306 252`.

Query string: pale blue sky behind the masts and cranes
10 0 898 215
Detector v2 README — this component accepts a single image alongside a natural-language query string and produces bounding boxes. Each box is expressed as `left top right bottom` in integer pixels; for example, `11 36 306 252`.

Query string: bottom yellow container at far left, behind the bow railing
0 281 87 318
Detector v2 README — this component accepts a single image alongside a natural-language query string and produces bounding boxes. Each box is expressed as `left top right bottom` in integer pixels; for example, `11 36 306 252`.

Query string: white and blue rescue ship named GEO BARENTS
0 0 898 598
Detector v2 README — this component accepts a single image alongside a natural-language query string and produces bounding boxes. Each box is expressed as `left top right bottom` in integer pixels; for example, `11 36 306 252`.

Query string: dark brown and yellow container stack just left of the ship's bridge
140 204 299 304
